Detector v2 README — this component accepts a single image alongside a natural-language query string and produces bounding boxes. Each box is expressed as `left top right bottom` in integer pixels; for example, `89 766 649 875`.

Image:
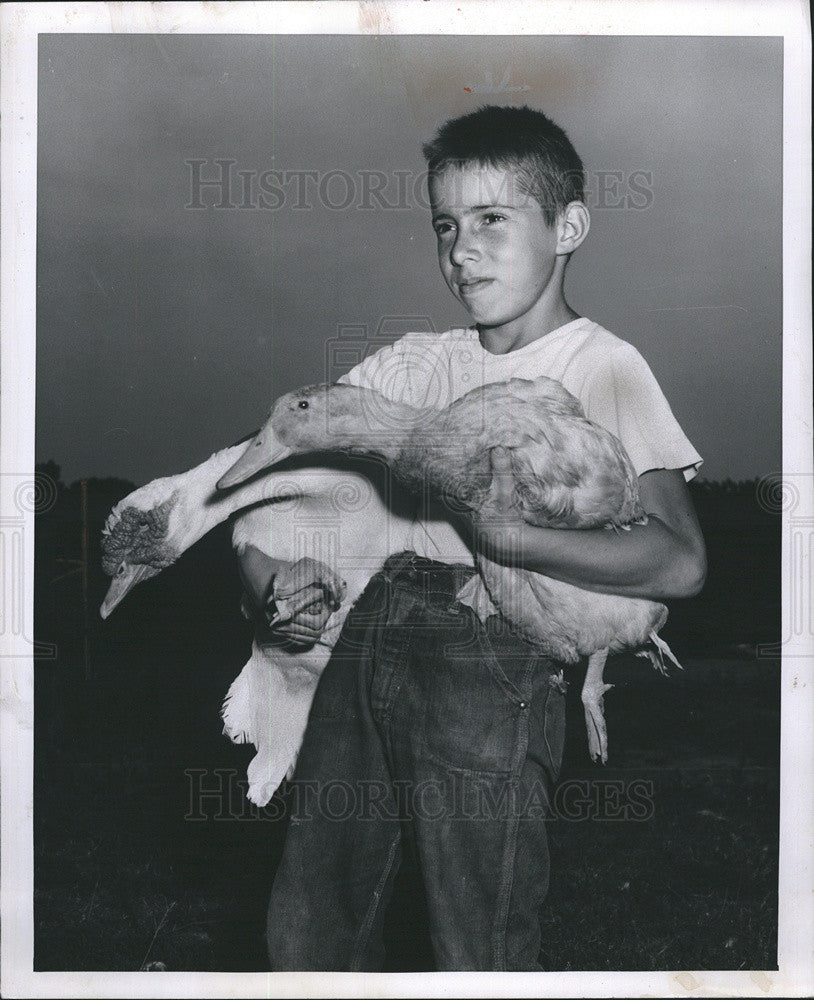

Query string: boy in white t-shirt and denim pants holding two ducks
243 107 705 970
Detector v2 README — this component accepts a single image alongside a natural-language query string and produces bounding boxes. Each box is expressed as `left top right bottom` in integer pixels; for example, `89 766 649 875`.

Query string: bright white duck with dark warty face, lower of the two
101 444 412 806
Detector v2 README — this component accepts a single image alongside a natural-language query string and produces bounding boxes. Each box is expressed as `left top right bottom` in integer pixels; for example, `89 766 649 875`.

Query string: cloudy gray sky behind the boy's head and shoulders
36 35 782 483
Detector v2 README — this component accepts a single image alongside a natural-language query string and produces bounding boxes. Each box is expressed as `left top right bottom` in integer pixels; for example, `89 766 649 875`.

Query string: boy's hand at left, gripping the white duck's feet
266 558 347 646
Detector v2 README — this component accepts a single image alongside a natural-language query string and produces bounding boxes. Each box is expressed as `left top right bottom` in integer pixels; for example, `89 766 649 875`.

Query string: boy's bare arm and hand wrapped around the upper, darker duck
472 448 706 601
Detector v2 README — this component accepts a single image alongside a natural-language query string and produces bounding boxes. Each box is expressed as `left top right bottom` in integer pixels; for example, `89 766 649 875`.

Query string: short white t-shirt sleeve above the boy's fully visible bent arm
582 344 703 480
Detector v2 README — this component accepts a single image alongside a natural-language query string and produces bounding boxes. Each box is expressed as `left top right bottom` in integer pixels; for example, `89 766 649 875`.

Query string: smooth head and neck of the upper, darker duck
218 383 418 490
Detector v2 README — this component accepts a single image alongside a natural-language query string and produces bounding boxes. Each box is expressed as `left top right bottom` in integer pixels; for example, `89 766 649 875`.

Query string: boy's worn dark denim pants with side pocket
268 552 565 971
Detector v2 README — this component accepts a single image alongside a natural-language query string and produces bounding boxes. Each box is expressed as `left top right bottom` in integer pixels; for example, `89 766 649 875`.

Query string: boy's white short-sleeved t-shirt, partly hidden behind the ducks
340 318 702 564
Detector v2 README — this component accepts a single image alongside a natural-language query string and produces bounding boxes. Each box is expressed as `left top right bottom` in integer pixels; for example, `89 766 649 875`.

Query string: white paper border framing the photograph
0 0 814 997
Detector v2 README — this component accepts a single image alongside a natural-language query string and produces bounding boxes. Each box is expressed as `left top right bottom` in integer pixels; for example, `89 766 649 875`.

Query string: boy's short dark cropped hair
423 105 585 226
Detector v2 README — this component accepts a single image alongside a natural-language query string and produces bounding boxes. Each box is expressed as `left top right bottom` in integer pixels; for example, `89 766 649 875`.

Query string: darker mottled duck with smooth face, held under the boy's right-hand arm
218 378 680 763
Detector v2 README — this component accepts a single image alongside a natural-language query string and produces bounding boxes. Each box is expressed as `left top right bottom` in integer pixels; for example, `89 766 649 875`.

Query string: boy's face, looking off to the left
430 165 558 329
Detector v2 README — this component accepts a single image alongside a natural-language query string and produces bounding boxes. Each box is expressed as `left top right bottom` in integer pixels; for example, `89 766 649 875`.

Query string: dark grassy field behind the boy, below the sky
35 472 780 971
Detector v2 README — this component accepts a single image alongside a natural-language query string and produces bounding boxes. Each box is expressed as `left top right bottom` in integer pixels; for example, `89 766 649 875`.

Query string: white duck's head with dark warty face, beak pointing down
100 479 184 618
